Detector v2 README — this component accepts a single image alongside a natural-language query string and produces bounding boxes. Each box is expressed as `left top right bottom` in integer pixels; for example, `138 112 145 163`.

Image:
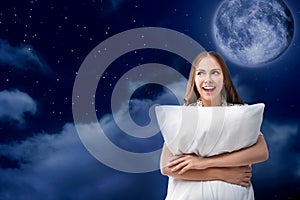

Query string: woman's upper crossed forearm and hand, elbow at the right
169 135 269 174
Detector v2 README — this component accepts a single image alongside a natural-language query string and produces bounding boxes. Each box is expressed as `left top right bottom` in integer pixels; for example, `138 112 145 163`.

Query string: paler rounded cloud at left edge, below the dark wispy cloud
0 90 37 125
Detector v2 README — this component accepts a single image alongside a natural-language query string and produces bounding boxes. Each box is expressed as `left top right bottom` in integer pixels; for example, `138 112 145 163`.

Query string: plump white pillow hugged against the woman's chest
155 103 265 156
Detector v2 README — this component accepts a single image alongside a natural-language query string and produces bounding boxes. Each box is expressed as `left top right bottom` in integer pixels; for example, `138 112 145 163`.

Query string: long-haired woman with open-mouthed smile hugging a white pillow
161 52 268 200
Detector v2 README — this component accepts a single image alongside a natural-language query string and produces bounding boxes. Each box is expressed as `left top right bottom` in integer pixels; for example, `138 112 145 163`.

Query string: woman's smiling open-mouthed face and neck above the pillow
195 56 224 106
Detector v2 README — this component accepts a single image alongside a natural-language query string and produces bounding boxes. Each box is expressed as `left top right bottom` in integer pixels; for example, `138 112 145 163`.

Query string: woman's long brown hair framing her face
184 51 244 105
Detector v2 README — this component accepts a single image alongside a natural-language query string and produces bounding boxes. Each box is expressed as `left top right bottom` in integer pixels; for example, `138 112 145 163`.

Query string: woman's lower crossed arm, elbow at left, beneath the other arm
160 145 252 187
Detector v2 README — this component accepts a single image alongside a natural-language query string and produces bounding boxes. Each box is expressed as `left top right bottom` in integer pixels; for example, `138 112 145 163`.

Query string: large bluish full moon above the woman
213 0 294 67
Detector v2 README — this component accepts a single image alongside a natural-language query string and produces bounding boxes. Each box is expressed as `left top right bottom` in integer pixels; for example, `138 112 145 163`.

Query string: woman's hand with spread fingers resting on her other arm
168 154 209 174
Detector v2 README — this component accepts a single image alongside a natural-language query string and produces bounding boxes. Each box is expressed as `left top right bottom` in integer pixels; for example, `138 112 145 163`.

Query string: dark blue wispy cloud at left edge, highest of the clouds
0 39 49 72
